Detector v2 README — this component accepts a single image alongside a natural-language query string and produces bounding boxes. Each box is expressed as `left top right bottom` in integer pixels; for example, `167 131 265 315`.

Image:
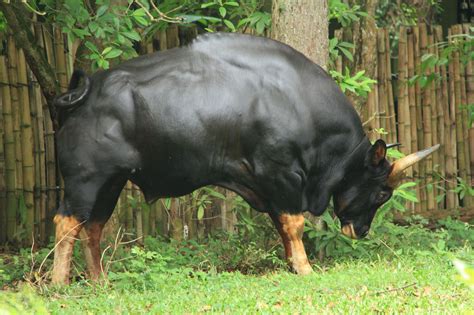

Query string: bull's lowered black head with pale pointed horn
334 140 439 238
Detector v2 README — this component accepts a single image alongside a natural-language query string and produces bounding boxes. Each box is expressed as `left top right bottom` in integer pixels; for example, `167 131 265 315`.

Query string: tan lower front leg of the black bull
270 214 313 275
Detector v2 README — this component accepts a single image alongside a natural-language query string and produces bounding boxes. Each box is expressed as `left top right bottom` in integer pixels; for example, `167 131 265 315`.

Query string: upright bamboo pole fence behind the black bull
0 25 474 244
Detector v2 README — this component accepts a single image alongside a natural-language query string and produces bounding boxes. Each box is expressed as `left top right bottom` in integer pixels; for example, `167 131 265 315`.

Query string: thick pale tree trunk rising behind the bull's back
272 0 329 260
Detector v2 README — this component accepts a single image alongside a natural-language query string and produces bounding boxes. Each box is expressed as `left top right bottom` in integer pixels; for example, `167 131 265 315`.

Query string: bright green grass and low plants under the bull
0 217 474 314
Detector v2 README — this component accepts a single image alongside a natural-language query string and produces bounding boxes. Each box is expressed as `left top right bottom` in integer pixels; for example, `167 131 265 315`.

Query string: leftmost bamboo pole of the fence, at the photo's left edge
0 56 17 244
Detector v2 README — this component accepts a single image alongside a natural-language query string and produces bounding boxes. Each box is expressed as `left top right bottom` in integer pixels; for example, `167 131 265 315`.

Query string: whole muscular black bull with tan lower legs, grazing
53 34 436 283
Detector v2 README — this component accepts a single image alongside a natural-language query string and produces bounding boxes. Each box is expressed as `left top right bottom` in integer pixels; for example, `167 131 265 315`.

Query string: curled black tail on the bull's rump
54 70 91 109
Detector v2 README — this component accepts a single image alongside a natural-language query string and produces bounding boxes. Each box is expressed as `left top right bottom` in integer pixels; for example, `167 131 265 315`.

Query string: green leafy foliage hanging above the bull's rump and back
19 0 271 70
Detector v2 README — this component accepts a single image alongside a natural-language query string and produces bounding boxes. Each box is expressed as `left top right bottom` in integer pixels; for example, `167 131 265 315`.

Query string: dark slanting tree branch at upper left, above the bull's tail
0 1 60 129
